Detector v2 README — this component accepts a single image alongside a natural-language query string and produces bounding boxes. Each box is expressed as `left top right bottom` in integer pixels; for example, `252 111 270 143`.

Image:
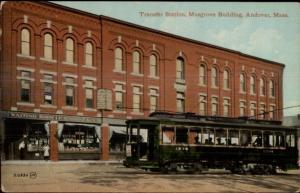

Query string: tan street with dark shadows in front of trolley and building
1 161 300 193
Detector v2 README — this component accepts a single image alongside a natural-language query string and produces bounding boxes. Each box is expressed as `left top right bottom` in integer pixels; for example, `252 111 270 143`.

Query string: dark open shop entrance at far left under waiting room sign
4 119 49 160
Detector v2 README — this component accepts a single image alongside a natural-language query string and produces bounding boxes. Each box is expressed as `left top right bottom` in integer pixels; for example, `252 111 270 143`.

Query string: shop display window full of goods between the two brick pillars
59 123 100 153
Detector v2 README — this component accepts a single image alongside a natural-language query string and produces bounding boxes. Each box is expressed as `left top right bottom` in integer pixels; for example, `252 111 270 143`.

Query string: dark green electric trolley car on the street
124 112 298 174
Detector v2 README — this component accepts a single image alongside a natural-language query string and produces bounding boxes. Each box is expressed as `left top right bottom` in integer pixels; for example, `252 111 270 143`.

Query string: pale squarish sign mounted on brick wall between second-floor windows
97 89 112 110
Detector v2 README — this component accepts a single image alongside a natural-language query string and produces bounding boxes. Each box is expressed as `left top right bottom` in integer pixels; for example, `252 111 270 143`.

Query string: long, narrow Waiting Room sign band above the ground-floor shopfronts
1 111 101 124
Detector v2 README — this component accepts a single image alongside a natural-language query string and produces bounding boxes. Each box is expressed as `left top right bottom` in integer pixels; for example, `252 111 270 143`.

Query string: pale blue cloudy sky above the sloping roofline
54 1 300 116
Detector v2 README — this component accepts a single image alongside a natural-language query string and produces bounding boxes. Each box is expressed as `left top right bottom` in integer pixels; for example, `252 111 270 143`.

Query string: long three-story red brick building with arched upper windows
0 2 284 160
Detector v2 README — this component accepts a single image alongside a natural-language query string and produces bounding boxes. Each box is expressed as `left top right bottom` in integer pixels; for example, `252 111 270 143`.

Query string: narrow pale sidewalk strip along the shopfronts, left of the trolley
1 160 123 165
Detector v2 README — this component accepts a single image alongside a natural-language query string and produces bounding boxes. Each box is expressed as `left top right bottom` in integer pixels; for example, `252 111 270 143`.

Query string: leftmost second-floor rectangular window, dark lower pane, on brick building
21 71 31 102
